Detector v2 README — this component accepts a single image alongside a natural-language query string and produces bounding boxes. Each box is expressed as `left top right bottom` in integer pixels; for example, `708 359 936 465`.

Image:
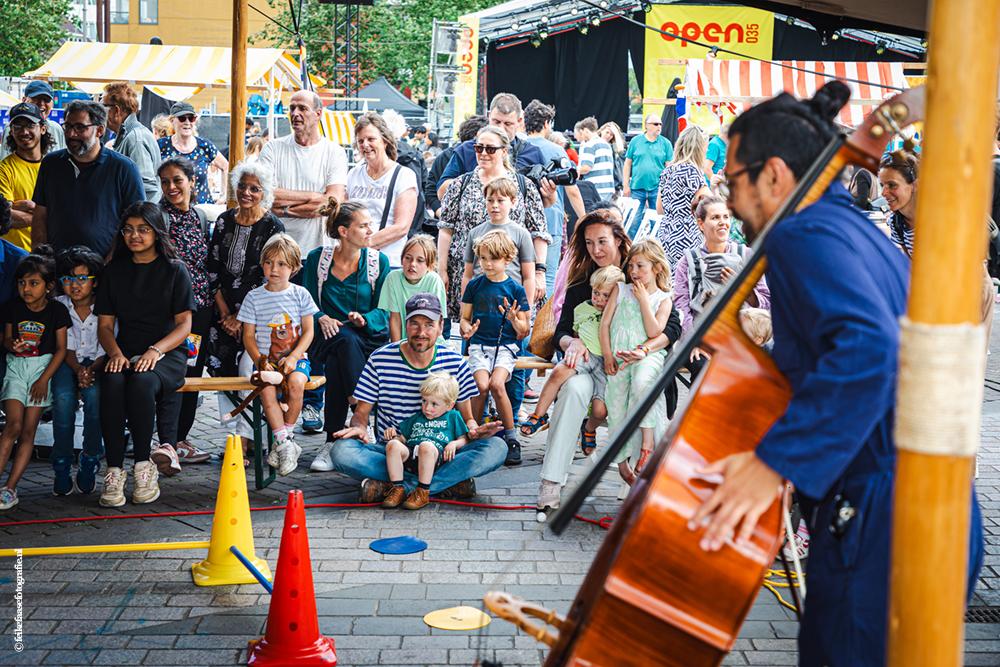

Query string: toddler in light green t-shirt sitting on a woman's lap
521 265 625 453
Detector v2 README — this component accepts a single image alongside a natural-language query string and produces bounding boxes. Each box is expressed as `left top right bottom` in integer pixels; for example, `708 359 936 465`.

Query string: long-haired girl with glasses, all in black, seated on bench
94 202 196 507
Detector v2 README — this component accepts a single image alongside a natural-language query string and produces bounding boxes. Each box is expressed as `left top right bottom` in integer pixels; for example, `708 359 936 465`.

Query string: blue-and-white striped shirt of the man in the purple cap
354 341 479 438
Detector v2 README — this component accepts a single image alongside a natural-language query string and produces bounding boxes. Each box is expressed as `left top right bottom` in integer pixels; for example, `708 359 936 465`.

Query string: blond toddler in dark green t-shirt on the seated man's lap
382 373 469 510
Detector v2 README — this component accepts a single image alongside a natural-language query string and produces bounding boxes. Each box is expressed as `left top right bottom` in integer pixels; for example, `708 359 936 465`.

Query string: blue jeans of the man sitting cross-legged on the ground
330 438 507 495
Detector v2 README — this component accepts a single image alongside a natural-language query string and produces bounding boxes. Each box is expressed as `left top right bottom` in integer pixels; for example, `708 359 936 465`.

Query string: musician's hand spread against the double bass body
688 452 784 551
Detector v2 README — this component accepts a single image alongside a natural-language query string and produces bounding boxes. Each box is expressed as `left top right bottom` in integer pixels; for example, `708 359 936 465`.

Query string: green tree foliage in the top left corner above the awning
0 0 70 76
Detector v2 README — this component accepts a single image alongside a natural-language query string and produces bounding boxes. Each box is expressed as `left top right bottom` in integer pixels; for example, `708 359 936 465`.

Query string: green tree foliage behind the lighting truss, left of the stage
253 0 497 95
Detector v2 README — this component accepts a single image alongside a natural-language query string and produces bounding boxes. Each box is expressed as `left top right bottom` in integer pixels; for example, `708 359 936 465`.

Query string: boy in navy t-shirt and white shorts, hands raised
460 230 531 462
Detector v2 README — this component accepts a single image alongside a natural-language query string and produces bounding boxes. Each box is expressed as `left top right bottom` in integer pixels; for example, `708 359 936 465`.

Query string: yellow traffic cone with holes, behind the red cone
191 435 271 586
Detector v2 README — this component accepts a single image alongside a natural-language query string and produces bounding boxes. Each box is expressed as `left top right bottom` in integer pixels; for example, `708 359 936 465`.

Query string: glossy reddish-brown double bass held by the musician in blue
484 88 924 667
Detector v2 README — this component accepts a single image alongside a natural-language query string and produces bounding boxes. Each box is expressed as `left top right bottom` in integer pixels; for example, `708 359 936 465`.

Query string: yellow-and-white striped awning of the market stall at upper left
24 42 325 100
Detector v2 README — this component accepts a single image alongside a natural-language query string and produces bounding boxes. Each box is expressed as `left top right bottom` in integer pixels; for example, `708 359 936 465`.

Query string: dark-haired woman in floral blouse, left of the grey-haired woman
151 157 214 476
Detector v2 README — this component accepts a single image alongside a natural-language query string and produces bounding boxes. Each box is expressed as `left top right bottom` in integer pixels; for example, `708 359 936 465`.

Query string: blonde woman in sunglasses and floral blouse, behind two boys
438 125 558 321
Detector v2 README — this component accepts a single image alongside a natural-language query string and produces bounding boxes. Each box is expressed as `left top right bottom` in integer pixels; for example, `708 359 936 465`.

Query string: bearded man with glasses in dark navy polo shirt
31 100 146 257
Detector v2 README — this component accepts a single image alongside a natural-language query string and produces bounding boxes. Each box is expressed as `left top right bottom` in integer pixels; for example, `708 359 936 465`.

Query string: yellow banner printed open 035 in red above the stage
643 5 774 125
